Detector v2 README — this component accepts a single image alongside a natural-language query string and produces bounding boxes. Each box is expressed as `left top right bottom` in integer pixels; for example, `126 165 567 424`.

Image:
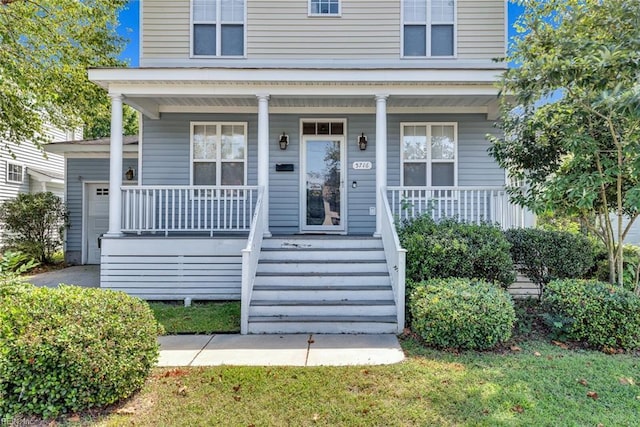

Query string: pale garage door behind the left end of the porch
85 183 109 264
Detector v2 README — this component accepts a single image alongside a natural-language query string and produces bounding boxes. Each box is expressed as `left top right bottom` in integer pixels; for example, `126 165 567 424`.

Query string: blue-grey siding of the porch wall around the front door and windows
141 113 505 234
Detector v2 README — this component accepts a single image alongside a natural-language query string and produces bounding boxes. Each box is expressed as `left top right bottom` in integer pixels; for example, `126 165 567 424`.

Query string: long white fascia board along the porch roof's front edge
88 68 504 88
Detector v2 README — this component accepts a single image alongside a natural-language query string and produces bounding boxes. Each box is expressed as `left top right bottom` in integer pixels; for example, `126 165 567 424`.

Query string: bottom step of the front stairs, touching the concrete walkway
249 316 398 334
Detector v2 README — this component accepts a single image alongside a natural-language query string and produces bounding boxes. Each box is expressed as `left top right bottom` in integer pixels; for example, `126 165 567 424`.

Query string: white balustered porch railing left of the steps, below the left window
121 186 258 235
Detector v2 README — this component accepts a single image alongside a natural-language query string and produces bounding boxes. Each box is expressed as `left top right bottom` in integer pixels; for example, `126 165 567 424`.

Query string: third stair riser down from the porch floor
257 260 389 275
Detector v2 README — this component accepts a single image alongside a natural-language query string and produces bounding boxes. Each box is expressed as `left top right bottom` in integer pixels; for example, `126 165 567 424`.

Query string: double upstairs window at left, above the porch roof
191 0 246 56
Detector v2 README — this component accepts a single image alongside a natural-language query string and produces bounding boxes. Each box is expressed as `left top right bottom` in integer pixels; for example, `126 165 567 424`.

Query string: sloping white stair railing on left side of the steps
240 188 266 335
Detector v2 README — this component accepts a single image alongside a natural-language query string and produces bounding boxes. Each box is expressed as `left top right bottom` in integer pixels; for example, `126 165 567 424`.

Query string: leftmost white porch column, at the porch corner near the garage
107 93 122 236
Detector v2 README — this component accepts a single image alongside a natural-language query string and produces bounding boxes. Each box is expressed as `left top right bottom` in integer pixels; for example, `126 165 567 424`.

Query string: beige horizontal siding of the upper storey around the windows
140 0 506 66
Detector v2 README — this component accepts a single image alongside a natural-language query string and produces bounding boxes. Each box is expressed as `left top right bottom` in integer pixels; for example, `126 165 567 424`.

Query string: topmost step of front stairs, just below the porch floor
262 236 383 249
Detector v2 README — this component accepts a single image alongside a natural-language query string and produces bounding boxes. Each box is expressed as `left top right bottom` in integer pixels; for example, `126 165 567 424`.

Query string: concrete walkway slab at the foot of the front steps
158 334 404 366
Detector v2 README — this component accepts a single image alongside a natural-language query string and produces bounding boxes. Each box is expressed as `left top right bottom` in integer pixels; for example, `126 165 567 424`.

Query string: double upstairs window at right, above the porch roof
402 0 456 57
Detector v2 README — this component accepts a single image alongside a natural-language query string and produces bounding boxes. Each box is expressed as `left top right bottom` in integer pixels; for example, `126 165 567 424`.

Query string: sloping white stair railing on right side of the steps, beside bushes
380 189 407 333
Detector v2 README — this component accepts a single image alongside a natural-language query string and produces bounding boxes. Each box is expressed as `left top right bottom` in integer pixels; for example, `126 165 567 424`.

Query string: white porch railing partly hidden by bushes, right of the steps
387 187 526 229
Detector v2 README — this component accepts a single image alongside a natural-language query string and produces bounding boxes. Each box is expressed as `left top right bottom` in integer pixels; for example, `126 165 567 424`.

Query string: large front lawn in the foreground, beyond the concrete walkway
99 340 640 426
